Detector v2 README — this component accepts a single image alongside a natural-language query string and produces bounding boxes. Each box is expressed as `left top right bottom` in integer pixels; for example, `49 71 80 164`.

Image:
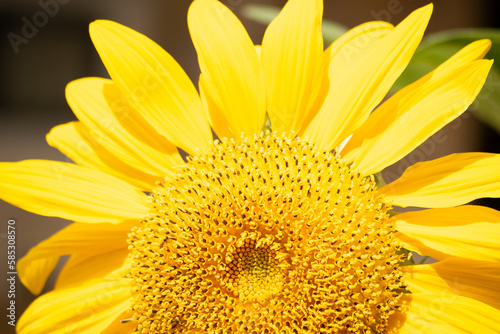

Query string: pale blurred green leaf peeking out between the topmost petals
241 4 347 45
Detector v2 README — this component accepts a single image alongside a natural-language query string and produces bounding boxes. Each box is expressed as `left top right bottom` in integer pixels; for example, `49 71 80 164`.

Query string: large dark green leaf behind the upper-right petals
391 28 500 133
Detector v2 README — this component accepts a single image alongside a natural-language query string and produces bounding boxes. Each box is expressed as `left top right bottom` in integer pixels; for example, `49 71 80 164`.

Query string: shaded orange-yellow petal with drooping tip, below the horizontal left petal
17 223 135 295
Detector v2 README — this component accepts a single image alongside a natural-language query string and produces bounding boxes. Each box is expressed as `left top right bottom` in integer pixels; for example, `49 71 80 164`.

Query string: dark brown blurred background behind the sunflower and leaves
0 0 500 333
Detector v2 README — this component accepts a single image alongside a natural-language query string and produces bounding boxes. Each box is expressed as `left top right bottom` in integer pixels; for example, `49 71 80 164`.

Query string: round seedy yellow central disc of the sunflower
129 133 407 333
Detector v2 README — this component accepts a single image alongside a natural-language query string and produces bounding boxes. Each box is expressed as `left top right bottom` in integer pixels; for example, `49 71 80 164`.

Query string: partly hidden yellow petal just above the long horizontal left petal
46 122 157 191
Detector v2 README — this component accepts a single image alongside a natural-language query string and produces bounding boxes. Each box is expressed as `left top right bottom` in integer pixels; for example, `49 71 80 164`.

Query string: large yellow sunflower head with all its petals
0 0 500 334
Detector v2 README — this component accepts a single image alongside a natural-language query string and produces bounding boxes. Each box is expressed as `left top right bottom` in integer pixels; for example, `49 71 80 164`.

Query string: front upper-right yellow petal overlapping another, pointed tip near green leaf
343 56 492 175
